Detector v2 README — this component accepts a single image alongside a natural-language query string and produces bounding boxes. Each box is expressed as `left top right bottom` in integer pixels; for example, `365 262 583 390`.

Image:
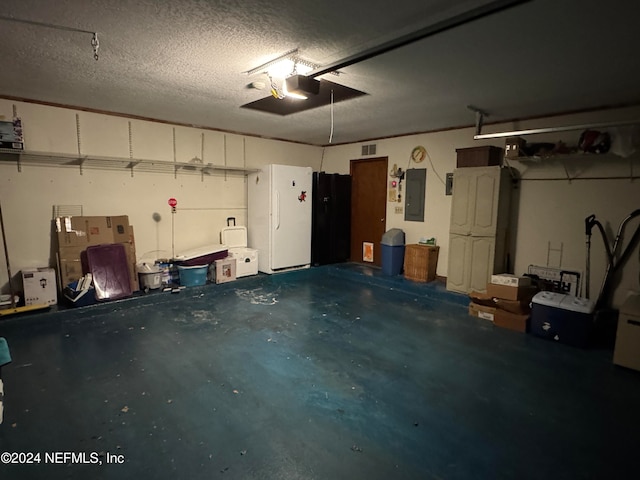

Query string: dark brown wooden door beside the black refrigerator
350 157 387 266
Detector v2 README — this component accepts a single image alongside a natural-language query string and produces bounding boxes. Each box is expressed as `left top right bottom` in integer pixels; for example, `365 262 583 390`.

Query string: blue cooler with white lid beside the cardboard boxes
531 292 595 348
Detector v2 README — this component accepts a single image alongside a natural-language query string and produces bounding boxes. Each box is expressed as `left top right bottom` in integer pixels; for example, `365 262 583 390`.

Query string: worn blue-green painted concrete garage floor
0 264 640 480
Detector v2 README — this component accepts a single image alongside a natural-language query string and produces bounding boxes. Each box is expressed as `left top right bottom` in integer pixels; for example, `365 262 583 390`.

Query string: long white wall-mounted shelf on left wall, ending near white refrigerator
0 148 257 177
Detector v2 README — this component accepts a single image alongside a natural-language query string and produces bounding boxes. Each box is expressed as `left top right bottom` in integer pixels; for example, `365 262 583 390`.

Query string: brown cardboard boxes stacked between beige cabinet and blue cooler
469 274 538 332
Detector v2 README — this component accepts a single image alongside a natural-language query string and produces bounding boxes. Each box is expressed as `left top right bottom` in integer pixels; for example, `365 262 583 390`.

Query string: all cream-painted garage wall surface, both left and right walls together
0 99 640 304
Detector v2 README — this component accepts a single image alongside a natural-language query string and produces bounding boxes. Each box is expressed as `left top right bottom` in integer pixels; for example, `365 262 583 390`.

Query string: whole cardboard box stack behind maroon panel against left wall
55 215 140 292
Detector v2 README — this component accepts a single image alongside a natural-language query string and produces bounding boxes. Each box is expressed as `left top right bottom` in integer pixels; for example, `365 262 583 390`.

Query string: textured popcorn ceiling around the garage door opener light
0 0 640 145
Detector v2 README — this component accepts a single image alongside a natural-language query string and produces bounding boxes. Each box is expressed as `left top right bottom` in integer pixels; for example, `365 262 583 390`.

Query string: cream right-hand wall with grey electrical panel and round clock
323 108 640 305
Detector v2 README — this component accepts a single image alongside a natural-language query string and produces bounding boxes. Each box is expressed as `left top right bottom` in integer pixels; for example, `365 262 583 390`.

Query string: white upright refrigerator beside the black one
247 165 313 273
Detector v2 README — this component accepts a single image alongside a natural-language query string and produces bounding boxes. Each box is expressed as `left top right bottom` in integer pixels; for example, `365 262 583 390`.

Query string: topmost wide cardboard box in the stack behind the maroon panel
56 215 131 247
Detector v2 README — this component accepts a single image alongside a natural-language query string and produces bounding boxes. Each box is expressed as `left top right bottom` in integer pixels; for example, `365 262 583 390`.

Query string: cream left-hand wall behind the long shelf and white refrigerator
0 100 322 291
